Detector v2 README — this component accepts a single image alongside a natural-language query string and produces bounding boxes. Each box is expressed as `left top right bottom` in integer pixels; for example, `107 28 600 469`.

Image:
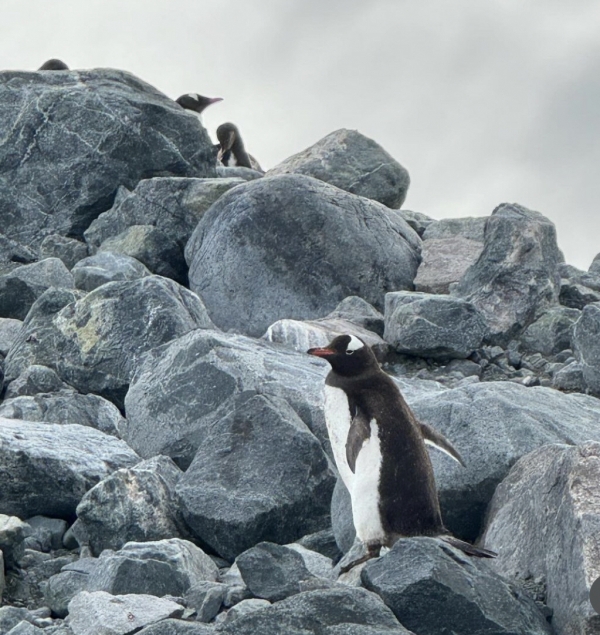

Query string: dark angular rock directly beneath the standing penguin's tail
361 537 552 635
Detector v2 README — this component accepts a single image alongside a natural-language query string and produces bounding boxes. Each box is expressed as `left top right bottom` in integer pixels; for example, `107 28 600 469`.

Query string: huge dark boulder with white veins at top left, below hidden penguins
0 69 215 247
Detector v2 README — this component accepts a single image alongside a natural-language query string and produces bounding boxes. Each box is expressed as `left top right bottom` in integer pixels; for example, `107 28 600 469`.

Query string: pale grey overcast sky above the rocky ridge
0 0 600 269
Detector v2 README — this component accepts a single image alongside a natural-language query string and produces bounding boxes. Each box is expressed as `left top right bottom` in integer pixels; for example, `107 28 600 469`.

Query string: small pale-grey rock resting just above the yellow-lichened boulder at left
71 251 151 291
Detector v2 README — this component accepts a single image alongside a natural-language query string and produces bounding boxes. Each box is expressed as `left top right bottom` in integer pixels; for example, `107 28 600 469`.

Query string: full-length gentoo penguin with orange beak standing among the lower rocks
308 335 496 571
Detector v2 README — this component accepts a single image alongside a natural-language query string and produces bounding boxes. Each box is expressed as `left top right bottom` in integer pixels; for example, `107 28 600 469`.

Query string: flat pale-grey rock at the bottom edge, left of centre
68 591 183 635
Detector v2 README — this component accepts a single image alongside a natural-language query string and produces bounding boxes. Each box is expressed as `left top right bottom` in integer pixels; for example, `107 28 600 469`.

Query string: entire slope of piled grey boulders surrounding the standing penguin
0 69 600 635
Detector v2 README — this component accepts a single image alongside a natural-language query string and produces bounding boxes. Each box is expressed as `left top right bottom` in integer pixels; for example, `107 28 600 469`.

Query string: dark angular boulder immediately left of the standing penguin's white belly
177 395 334 560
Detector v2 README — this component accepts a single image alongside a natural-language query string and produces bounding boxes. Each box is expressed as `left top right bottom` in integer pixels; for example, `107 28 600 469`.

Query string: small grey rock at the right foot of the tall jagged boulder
520 307 581 357
